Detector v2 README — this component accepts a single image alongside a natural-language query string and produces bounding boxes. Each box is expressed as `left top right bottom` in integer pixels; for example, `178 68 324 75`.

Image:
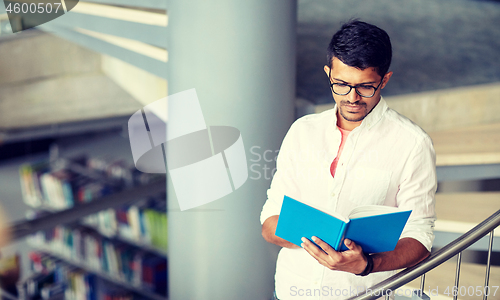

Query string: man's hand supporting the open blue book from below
301 236 367 274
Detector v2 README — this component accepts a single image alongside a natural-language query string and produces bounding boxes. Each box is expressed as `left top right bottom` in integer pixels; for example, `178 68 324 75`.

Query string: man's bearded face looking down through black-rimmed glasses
324 57 392 130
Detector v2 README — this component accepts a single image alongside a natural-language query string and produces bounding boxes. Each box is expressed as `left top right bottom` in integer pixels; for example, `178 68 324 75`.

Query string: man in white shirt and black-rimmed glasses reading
261 21 437 300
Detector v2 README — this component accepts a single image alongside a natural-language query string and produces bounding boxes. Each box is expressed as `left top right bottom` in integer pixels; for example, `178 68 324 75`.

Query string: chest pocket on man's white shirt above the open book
349 167 392 205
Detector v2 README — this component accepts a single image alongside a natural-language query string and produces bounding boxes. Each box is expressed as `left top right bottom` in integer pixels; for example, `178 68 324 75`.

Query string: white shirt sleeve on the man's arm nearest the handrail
397 136 437 251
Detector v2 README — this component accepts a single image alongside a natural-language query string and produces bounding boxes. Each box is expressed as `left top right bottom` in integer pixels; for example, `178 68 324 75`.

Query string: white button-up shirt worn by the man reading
260 98 437 300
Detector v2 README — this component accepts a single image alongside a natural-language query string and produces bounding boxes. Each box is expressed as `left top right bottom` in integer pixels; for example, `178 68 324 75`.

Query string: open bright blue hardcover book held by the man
275 196 411 253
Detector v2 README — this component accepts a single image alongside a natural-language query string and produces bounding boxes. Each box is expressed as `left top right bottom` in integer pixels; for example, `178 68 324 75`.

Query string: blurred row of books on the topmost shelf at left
19 156 160 210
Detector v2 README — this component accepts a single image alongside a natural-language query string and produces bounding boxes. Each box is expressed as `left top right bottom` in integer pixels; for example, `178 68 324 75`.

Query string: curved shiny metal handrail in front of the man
348 210 500 300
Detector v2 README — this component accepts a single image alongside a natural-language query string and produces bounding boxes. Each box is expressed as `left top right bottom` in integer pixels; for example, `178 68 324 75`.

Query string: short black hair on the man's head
327 20 392 77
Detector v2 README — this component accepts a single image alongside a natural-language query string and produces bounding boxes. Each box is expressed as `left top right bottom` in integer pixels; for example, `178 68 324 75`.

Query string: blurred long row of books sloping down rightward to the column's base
28 225 167 294
